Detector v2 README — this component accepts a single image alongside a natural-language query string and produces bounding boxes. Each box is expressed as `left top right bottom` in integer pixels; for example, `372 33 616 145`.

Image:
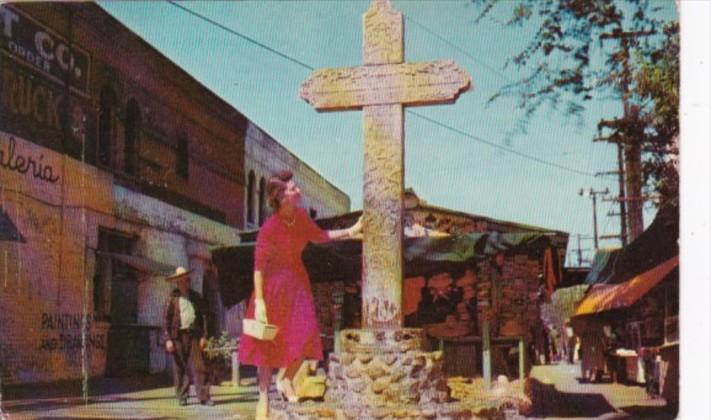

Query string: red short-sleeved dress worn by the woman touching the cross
239 208 328 368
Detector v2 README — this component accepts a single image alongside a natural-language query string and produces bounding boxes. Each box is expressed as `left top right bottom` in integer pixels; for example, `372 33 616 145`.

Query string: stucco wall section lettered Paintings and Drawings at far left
0 132 111 382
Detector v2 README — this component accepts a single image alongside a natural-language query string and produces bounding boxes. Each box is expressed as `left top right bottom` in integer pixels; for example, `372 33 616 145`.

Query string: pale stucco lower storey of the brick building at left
0 132 239 383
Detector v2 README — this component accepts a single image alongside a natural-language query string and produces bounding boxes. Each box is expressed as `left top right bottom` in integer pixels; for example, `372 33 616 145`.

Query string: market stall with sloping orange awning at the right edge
573 207 679 403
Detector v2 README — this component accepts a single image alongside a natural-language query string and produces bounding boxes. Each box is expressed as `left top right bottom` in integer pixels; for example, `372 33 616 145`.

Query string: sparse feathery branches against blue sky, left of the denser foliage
472 0 664 115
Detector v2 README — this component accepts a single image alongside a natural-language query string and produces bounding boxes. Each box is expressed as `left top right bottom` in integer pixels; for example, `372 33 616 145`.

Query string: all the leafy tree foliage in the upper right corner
472 0 679 207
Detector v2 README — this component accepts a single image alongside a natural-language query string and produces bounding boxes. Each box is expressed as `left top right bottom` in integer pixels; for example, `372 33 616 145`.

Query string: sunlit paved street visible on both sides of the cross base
2 364 674 420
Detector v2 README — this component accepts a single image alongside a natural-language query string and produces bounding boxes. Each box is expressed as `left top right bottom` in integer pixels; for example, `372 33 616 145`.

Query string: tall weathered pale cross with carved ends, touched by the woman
300 0 471 328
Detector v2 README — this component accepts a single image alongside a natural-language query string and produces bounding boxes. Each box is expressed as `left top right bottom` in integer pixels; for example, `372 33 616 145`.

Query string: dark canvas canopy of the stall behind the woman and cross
212 232 556 307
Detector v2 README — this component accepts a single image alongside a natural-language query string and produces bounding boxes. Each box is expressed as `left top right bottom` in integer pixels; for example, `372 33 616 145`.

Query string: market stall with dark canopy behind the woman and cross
213 232 560 388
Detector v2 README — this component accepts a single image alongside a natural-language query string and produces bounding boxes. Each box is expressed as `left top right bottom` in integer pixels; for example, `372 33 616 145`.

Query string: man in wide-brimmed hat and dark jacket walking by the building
164 267 214 406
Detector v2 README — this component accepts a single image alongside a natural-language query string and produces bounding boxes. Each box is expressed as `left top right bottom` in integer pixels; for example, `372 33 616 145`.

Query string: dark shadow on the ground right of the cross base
528 379 617 417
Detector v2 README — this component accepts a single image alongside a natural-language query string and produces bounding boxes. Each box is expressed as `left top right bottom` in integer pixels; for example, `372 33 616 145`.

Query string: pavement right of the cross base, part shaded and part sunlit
529 363 676 420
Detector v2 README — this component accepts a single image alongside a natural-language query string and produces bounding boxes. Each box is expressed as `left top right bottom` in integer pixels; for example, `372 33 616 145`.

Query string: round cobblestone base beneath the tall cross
271 328 471 419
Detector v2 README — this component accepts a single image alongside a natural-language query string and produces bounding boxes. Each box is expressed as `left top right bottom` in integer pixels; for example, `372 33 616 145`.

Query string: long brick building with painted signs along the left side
0 3 348 383
